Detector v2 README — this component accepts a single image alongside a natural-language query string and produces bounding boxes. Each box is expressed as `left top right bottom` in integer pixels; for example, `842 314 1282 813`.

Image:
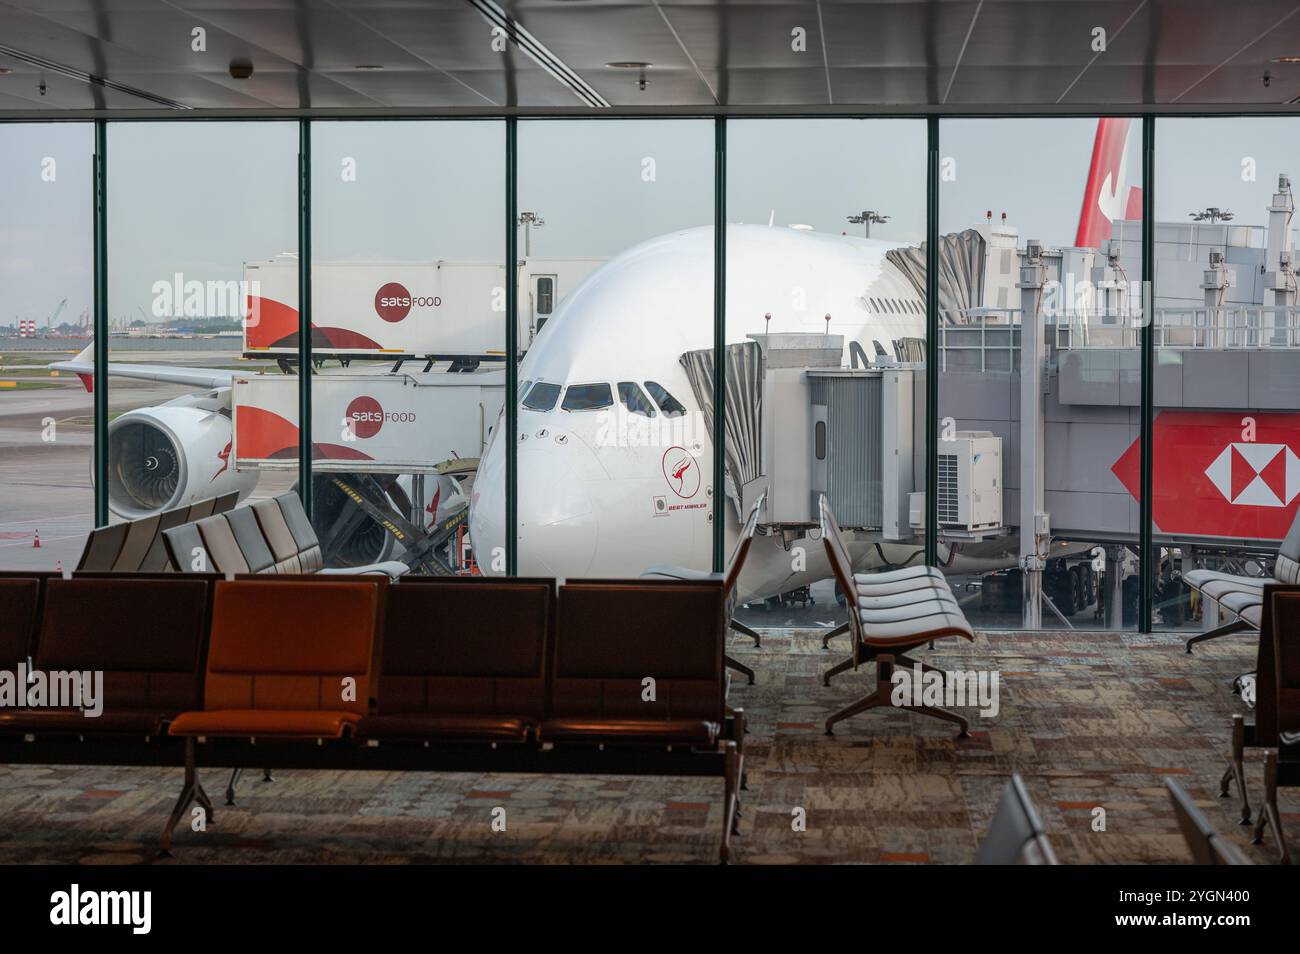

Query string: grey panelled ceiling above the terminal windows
0 0 1300 114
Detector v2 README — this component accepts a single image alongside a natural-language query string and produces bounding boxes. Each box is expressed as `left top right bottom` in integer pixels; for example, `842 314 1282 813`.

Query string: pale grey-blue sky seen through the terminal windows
0 117 1300 325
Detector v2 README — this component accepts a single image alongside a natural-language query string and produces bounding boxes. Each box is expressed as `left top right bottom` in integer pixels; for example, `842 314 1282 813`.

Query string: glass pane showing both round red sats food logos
312 121 506 573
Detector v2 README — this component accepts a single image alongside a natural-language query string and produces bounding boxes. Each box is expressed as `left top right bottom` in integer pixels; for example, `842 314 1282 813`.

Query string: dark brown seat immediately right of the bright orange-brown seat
356 577 555 745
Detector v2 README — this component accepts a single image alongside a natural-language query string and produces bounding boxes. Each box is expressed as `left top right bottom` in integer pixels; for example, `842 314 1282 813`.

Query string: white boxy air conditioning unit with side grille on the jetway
935 430 1002 533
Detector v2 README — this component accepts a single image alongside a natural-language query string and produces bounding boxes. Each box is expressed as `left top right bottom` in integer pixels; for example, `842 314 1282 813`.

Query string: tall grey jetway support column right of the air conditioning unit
1019 240 1048 629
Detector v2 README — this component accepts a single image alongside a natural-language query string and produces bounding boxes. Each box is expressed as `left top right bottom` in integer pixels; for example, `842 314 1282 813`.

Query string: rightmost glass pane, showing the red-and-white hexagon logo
1152 117 1300 636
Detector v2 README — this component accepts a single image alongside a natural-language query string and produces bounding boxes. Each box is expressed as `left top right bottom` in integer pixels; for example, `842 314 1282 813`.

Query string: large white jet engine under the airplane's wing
108 398 257 520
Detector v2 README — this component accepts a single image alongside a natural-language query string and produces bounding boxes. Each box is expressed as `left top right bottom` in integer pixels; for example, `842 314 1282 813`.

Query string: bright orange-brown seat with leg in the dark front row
161 578 381 853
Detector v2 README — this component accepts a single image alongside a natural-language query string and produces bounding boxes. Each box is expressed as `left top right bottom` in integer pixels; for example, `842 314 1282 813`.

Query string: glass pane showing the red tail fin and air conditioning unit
936 118 1143 629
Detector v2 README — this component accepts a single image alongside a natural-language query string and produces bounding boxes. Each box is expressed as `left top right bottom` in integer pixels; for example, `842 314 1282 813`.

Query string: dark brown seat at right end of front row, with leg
538 580 744 862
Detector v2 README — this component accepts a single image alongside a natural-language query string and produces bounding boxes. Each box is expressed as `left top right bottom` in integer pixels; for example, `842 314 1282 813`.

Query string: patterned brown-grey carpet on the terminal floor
0 630 1300 864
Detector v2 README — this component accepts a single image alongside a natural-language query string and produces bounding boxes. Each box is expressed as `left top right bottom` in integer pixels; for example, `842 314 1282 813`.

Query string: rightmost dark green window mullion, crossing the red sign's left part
1138 116 1157 633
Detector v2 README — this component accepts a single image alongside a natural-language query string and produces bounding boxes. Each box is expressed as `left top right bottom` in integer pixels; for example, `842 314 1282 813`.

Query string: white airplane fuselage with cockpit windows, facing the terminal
471 225 1005 598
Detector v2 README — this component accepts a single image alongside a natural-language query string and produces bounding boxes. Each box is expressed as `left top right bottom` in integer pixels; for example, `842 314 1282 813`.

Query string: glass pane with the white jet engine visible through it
108 122 298 572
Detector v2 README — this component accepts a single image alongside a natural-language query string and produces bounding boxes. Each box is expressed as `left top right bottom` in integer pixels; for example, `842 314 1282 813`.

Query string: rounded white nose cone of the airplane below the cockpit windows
471 429 603 577
